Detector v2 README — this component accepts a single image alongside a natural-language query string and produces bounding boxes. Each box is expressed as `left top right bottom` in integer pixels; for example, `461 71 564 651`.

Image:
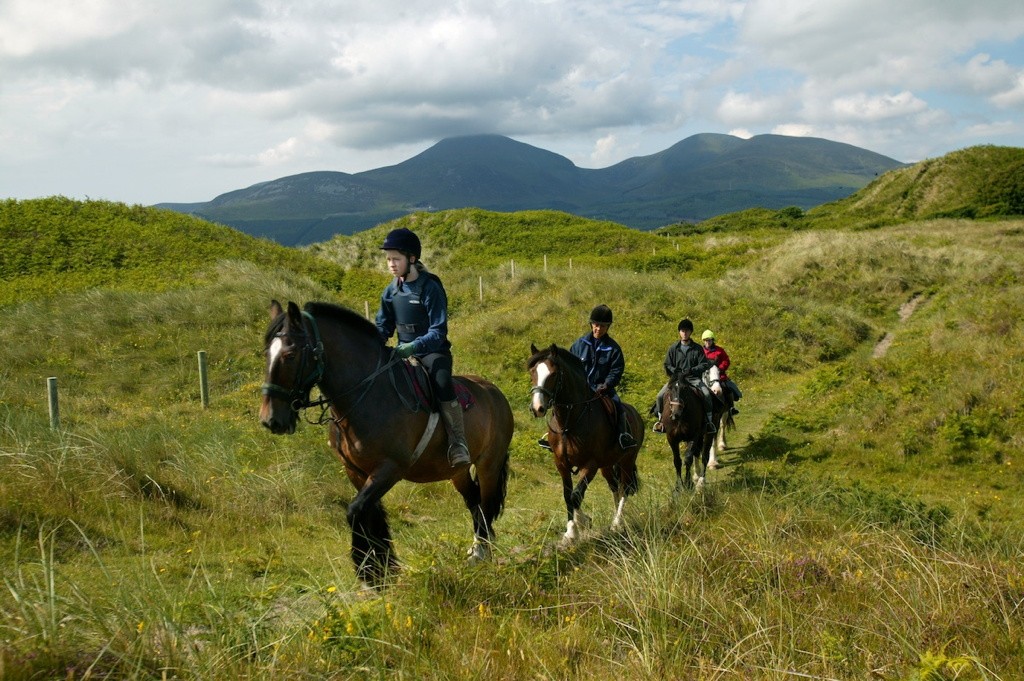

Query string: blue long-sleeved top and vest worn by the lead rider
376 271 452 356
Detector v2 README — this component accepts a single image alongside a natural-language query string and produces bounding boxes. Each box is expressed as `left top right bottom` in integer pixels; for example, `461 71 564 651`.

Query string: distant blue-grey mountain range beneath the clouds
159 133 903 245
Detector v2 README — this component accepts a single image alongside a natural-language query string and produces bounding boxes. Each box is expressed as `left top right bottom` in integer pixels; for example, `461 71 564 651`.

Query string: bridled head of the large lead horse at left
260 300 324 435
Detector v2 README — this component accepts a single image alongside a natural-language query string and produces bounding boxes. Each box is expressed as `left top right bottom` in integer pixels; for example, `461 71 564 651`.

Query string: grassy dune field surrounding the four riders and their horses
0 195 1024 679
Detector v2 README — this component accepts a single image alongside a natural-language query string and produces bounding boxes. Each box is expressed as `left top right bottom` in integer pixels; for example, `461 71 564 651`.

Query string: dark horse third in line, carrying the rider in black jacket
662 369 731 494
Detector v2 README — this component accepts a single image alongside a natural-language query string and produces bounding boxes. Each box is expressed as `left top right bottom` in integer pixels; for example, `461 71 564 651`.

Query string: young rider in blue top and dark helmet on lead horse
376 227 470 466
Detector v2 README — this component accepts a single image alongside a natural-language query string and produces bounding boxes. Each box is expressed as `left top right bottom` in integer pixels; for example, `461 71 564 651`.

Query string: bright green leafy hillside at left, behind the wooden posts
0 197 344 305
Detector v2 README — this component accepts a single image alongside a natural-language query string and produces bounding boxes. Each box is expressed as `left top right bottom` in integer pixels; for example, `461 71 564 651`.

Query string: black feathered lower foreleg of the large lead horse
345 474 398 589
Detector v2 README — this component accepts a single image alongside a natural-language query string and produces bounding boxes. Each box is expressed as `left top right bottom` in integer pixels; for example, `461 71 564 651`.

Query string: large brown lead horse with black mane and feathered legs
260 300 513 587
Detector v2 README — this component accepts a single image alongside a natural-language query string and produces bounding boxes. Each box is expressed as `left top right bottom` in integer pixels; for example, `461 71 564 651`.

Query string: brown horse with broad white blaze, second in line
526 345 644 546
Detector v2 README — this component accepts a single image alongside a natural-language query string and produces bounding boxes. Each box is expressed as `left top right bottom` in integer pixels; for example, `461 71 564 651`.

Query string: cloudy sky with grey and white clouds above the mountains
0 0 1024 204
